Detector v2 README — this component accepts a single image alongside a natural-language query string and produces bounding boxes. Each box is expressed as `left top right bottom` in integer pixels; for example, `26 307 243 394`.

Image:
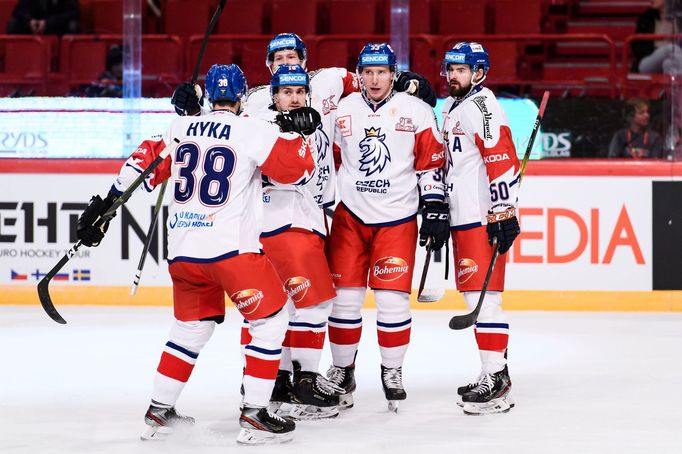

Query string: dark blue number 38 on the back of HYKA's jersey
175 143 236 206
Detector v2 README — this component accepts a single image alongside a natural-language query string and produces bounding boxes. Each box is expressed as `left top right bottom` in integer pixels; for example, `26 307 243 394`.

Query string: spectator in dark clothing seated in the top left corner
7 0 80 35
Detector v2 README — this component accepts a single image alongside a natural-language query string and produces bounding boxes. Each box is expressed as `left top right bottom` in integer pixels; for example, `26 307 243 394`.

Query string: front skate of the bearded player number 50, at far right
458 366 514 415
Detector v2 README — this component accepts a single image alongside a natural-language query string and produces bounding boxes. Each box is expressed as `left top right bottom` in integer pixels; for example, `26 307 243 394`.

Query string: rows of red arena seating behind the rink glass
0 0 669 97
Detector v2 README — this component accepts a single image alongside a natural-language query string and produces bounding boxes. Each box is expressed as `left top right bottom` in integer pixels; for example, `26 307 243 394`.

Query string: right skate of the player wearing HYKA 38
237 406 296 445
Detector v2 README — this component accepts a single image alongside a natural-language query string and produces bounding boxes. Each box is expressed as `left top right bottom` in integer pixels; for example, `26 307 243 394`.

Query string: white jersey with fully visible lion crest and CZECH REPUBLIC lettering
334 93 445 226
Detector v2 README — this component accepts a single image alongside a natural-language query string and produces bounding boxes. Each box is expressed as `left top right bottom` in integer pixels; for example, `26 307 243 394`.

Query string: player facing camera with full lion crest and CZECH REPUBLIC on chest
328 43 449 410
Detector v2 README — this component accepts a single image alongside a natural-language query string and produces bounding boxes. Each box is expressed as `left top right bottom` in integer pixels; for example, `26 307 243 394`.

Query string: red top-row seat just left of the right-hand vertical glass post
329 0 378 34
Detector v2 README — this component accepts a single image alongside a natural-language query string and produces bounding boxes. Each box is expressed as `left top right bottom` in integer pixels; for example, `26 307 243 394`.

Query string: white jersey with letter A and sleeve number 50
442 87 519 230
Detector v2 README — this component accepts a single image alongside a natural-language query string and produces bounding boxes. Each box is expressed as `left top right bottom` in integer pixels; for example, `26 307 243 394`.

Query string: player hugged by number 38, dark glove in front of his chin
242 64 342 419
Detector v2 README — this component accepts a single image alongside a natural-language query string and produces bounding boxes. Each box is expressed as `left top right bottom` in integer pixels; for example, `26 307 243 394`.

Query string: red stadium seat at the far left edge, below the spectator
0 36 50 96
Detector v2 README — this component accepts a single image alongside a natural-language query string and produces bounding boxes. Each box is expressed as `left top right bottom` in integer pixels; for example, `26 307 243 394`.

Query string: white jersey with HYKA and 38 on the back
113 111 314 263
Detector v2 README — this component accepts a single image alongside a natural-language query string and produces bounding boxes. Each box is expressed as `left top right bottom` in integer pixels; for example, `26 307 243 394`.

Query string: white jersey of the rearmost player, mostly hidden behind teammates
244 68 359 208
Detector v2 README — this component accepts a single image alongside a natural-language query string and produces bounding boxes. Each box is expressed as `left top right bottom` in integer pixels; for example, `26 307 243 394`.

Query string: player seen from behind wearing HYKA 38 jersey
78 65 314 444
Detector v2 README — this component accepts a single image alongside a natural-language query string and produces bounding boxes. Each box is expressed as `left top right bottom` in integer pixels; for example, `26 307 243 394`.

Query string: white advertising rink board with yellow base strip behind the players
0 159 682 311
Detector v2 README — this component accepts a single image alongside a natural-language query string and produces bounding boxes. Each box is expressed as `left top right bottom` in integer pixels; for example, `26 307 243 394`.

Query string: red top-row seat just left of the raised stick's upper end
163 0 213 37
